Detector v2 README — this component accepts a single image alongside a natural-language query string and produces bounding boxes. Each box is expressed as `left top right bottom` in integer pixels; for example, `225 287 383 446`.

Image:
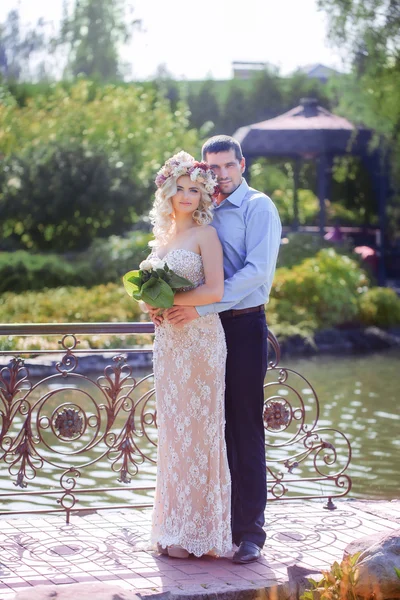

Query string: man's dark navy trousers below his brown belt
221 312 268 548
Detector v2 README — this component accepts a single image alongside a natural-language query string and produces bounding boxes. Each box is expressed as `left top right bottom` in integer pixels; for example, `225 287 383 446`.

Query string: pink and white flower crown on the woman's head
155 150 219 196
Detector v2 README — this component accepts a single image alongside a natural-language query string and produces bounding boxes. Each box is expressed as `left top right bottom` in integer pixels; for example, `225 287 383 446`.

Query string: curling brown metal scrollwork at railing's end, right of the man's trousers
264 334 351 508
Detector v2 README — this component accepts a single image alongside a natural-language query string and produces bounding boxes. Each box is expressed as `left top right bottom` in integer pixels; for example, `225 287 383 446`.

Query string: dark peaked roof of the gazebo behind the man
233 98 371 156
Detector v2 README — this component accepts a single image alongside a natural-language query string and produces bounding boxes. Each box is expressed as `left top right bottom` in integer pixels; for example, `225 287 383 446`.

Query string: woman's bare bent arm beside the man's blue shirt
174 226 224 306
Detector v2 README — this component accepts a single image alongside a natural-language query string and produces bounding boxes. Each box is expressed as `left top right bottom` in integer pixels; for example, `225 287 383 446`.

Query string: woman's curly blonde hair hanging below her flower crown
149 159 213 247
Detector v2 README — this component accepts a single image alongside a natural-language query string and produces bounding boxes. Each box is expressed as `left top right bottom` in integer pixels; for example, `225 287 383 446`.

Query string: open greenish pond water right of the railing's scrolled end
285 350 400 499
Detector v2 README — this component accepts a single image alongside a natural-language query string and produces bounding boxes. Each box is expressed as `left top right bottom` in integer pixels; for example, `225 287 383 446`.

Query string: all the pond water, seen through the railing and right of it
0 350 400 510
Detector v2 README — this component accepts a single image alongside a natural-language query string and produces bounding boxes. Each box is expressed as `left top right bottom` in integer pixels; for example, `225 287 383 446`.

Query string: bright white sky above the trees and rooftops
0 0 344 80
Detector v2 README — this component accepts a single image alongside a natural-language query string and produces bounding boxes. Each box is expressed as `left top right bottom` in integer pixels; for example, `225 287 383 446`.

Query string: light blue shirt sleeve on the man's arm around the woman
196 210 282 316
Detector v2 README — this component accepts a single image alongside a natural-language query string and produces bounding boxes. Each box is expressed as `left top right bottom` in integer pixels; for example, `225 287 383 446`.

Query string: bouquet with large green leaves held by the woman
123 260 193 308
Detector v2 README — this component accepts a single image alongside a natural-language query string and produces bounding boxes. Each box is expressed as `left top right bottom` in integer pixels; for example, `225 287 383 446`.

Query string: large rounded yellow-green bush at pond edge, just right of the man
271 248 369 329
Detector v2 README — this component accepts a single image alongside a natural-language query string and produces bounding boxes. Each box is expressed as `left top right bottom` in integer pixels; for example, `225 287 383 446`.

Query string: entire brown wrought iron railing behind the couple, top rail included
0 323 351 522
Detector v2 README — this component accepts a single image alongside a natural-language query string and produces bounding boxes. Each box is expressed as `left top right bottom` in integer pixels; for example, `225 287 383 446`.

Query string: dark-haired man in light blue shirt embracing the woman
165 135 282 563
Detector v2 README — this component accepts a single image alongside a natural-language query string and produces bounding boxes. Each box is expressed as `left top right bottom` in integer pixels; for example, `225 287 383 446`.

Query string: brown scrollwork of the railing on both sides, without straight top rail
0 326 351 518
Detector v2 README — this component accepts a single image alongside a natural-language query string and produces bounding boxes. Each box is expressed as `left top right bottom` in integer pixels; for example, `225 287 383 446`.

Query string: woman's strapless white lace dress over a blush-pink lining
149 249 232 556
